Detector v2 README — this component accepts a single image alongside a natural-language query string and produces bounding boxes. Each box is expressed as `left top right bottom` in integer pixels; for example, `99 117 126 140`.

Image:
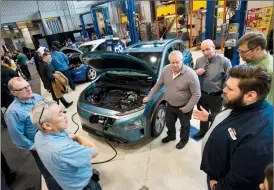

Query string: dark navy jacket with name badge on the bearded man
201 101 273 190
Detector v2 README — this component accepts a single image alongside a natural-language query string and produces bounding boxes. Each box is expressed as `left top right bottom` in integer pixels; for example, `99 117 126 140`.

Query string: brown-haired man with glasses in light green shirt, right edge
238 32 274 105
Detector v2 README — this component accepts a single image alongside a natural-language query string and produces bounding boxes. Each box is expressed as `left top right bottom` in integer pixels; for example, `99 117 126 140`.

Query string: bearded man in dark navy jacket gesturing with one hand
194 65 273 190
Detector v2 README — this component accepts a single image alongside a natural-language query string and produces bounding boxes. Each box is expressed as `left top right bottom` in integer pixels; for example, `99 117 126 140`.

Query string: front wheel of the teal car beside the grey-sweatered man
151 104 166 137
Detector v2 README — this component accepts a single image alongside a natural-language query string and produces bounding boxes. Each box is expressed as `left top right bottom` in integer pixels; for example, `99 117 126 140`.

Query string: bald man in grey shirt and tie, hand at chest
194 40 232 138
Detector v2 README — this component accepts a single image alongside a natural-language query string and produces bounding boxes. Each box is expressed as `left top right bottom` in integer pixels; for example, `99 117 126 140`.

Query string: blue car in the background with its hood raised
60 48 97 82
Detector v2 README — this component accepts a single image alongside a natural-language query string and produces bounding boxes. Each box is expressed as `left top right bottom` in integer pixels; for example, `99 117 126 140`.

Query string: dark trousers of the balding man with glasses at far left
30 150 62 190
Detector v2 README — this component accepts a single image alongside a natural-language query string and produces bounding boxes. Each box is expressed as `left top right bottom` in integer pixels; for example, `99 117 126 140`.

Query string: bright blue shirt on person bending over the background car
50 51 69 71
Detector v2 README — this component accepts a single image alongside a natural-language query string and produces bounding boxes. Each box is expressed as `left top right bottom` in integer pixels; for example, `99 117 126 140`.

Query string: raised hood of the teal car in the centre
82 52 157 81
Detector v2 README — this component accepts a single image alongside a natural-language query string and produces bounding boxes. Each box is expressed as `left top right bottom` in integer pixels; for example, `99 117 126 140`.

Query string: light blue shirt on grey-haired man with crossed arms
35 130 93 190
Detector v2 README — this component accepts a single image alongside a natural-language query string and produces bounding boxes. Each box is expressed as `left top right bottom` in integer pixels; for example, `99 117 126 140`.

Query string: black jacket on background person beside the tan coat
37 61 54 90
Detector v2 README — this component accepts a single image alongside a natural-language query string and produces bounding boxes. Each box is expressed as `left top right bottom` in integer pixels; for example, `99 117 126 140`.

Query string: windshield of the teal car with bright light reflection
128 52 162 74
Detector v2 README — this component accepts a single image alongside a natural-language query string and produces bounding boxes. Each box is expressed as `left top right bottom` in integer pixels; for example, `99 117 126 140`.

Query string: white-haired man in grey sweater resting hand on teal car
143 50 201 149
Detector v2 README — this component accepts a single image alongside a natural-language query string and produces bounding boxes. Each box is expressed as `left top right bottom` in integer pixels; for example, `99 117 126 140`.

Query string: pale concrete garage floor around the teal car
41 51 207 190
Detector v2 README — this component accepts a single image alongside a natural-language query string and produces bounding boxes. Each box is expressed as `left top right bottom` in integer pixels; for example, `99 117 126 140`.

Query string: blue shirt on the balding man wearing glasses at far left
4 94 45 150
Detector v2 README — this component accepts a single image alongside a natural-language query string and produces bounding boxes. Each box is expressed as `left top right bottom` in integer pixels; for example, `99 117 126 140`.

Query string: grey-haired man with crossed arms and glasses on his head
31 102 101 190
